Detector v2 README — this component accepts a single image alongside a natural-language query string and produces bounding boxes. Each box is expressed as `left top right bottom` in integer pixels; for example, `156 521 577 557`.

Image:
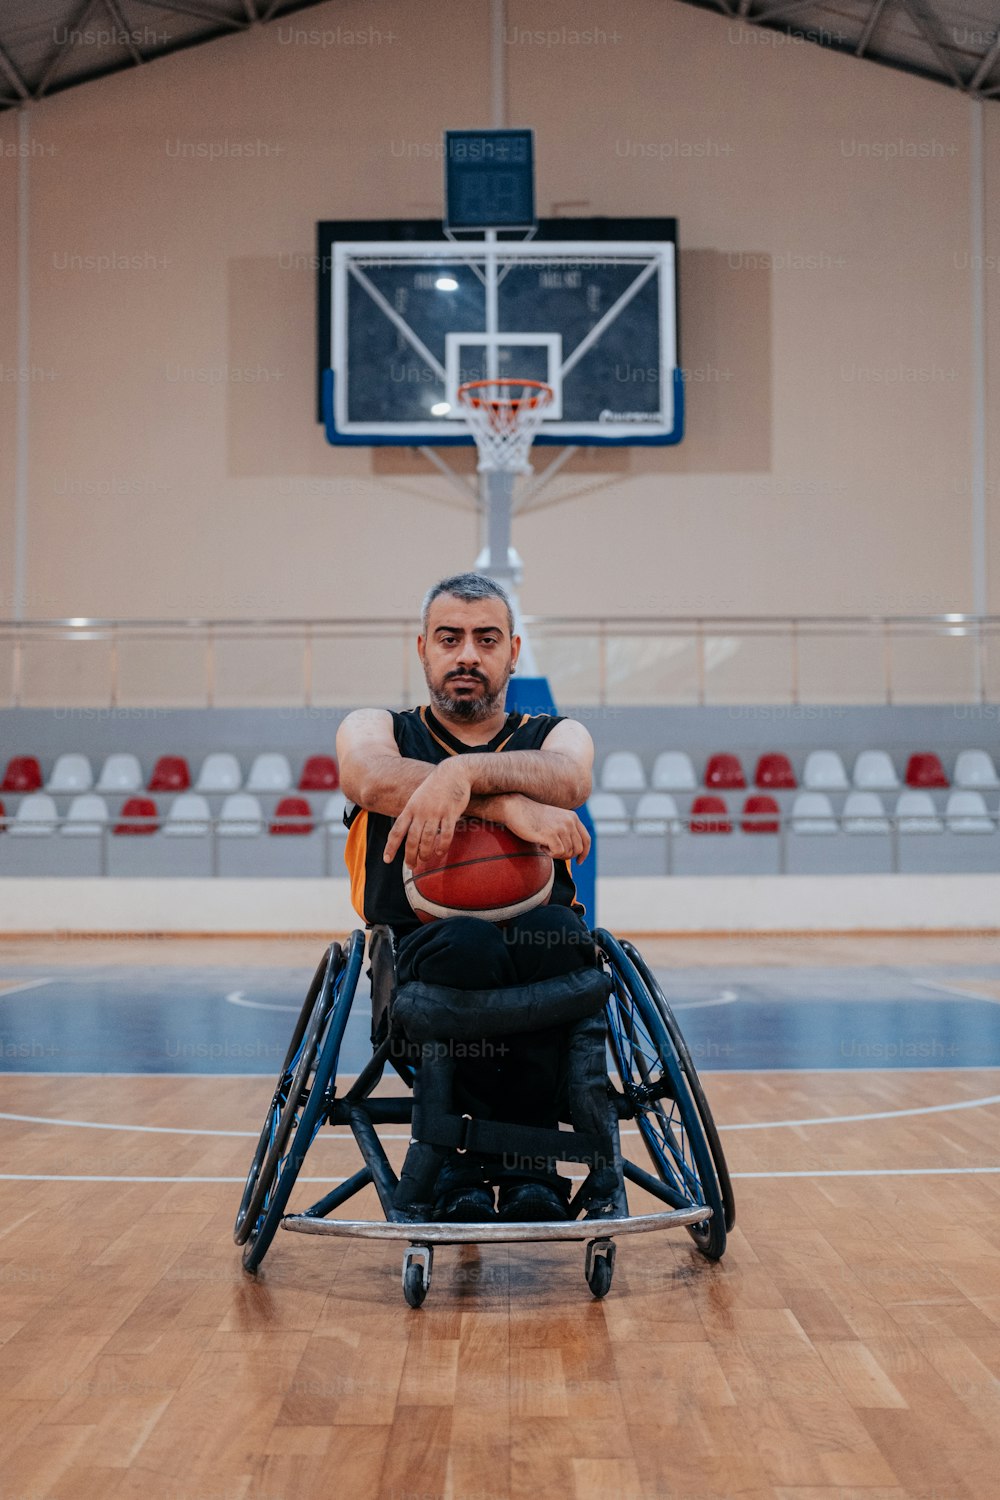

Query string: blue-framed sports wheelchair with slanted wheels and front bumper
234 926 736 1308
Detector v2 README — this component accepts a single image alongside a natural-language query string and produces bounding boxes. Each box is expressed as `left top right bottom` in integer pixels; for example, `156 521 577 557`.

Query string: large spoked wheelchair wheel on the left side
234 932 364 1271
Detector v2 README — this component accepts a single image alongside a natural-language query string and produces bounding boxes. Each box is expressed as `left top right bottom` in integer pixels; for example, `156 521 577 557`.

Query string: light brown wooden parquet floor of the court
0 938 1000 1500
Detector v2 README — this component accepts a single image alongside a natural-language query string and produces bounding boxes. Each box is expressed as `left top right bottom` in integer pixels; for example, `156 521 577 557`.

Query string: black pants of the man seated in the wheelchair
396 906 597 1197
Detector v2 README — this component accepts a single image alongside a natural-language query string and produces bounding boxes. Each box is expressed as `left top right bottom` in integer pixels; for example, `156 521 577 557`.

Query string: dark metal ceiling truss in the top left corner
0 0 332 110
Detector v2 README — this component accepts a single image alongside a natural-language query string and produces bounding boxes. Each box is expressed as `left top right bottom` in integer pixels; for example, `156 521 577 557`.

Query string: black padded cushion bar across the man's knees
393 969 612 1041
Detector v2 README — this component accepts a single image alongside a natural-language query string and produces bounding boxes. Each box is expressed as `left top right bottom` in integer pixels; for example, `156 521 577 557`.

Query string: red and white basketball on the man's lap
403 818 555 923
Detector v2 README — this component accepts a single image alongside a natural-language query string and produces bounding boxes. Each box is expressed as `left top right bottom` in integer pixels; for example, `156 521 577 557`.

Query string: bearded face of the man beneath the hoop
417 594 520 723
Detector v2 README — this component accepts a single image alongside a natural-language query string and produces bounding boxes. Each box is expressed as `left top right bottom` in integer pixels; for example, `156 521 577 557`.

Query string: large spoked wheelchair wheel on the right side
594 929 726 1260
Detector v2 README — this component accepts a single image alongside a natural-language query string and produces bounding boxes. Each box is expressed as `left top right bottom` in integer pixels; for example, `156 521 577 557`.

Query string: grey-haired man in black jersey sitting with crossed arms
337 573 603 1223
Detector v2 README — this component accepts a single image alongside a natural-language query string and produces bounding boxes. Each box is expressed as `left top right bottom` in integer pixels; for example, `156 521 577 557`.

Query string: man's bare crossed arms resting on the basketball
337 708 594 866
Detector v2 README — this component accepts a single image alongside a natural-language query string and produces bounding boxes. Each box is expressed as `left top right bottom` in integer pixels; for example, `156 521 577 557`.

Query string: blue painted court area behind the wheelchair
0 954 1000 1077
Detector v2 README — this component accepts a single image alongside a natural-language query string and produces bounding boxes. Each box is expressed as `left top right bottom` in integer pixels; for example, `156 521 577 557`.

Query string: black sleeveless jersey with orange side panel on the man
343 708 583 932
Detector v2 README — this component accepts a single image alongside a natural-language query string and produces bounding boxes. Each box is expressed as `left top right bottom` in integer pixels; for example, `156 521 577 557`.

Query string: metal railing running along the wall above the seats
0 614 1000 710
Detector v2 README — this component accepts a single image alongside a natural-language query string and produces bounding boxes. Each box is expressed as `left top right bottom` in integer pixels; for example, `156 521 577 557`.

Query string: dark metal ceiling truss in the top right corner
681 0 1000 99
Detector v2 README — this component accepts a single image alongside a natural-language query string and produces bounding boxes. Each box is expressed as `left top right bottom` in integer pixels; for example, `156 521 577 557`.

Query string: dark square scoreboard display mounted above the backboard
444 131 535 233
